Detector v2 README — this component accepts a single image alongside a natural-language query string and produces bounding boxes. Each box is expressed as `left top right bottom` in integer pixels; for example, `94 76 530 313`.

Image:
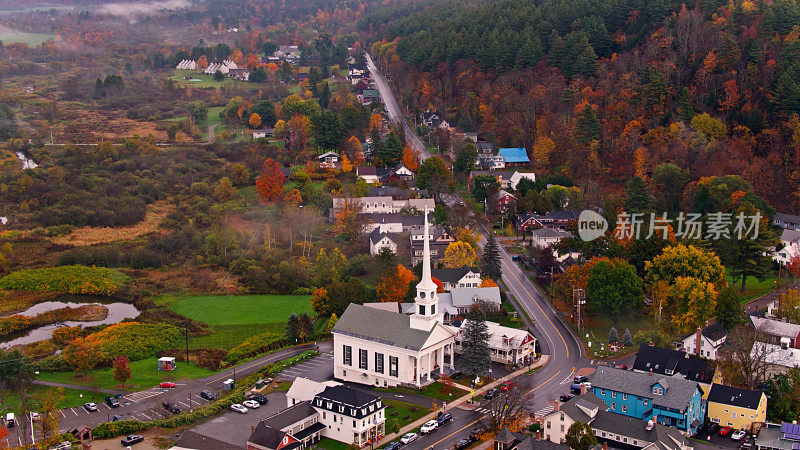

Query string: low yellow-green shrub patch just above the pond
0 265 129 295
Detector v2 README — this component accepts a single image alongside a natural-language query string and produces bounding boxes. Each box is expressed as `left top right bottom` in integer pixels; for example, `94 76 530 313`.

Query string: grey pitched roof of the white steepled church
332 303 438 350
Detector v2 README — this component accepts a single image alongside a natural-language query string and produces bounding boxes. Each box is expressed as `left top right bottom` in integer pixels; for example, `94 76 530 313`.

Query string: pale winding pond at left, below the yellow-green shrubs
0 295 139 348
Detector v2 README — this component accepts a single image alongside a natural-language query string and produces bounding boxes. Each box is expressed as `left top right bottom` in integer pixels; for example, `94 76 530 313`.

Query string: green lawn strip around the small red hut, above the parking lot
38 357 214 391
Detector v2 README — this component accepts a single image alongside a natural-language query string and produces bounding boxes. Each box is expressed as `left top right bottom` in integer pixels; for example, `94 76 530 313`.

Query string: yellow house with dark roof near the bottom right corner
708 384 767 430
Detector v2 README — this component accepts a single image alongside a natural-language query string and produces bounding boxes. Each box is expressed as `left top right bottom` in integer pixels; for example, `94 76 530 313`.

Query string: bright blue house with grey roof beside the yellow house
592 367 705 435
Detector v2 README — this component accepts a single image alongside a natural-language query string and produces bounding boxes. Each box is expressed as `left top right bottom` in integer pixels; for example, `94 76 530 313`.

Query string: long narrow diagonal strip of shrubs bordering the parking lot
92 350 319 439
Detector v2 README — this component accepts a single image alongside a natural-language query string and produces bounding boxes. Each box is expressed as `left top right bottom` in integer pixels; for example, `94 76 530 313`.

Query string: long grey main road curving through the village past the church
366 54 590 449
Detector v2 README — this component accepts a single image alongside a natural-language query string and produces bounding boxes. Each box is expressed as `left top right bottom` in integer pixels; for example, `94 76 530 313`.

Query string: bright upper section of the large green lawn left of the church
171 295 313 326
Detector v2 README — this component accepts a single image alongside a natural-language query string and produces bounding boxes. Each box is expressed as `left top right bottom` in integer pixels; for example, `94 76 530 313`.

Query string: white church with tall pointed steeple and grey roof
332 208 455 387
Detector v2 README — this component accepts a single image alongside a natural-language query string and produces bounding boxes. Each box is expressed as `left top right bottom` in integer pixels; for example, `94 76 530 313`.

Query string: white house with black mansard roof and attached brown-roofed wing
247 379 386 450
